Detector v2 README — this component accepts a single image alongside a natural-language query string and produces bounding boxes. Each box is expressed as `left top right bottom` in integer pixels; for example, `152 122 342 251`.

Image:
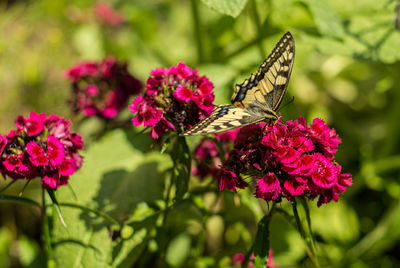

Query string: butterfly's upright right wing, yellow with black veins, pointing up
231 32 295 111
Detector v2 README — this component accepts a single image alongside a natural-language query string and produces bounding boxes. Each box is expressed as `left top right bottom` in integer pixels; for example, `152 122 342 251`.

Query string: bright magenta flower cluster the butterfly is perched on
219 117 352 206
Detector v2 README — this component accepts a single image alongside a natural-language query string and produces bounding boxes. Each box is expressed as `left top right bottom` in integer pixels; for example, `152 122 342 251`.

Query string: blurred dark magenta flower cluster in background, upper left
66 56 143 118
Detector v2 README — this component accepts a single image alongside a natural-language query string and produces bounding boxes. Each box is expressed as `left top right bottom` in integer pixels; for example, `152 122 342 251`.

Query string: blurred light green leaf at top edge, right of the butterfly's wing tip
302 0 344 38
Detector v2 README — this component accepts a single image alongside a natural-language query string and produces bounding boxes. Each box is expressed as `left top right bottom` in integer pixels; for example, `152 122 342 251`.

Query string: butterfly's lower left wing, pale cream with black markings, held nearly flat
182 105 265 136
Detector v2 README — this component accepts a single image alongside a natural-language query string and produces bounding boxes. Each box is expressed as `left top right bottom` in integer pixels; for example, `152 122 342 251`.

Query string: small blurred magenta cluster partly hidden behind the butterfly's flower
192 128 239 180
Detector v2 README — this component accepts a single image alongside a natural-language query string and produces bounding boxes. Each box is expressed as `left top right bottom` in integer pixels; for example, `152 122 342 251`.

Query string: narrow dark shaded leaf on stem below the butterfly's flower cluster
254 215 270 268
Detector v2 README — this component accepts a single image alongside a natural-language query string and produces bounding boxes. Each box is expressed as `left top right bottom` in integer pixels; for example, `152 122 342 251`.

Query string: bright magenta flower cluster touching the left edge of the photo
0 112 83 190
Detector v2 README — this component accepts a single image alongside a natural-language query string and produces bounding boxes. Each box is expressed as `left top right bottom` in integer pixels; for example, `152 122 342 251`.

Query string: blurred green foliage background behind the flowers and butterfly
0 0 400 267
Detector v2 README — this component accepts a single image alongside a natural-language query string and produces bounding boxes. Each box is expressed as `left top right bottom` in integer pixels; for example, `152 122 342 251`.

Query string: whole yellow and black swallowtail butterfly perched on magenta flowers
182 32 295 136
